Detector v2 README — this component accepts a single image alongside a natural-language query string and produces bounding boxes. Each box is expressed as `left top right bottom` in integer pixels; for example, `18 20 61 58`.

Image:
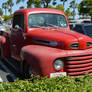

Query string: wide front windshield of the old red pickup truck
28 14 68 28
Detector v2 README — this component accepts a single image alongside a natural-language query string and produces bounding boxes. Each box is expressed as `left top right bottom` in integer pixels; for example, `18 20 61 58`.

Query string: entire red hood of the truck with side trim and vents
28 28 92 49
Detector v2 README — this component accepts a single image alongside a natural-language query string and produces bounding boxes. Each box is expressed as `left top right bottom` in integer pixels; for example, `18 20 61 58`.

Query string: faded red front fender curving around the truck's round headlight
21 45 64 77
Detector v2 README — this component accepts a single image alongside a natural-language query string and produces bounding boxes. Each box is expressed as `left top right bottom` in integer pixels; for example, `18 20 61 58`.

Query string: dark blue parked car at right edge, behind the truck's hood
71 23 92 37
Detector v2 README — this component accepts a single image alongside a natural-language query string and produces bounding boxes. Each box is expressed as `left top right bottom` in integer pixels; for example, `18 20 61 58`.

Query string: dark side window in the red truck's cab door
13 14 25 30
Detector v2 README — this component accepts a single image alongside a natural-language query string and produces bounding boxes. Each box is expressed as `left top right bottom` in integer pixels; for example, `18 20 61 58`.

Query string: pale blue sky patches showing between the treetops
0 0 82 18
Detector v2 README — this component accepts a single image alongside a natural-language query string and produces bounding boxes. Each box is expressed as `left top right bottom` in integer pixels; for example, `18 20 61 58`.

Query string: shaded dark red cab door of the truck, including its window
11 13 25 60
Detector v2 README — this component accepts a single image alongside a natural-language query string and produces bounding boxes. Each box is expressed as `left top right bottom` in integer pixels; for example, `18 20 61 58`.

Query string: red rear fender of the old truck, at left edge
0 36 11 57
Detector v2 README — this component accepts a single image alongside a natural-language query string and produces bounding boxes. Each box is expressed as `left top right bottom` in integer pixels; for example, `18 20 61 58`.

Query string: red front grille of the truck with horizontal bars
65 55 92 76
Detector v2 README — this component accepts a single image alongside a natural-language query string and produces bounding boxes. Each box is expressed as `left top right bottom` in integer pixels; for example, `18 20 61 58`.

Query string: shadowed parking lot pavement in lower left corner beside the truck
0 59 19 82
